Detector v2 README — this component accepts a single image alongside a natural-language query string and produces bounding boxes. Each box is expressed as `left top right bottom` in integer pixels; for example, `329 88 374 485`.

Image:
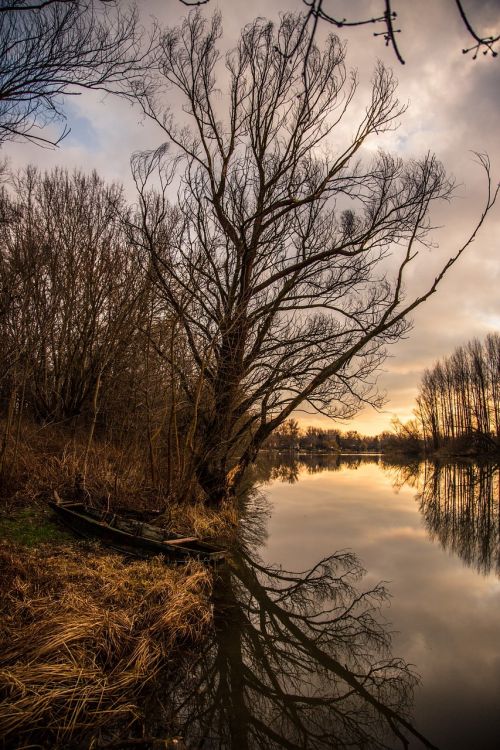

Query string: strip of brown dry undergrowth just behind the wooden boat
0 420 237 540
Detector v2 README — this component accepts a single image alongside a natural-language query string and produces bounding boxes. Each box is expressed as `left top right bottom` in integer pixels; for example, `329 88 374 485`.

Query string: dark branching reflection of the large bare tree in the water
153 496 433 750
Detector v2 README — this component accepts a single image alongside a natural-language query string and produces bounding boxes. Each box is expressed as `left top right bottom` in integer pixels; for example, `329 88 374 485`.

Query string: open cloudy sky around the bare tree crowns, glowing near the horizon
2 0 500 434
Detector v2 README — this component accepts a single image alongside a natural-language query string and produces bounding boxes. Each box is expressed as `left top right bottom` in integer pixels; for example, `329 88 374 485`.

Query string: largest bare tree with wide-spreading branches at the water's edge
133 13 497 501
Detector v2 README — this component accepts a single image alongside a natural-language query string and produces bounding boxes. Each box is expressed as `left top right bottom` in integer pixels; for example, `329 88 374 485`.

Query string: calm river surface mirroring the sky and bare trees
152 457 500 750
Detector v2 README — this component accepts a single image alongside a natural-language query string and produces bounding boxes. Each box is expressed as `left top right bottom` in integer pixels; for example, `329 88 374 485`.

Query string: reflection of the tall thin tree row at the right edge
417 463 500 575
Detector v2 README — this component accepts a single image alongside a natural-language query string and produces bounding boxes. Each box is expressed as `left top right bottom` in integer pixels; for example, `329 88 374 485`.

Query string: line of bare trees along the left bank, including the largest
0 12 498 503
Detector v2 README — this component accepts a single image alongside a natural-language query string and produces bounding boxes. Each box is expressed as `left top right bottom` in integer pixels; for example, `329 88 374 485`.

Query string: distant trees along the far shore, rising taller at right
267 333 500 454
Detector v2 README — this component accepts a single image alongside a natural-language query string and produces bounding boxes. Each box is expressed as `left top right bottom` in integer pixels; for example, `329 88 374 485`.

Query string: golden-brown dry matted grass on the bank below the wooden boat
0 545 211 748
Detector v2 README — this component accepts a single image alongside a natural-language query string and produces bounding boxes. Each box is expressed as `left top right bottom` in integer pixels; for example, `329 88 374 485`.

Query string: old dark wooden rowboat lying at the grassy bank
49 500 225 562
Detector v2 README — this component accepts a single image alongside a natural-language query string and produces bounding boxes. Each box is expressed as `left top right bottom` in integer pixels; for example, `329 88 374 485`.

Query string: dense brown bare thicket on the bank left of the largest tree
0 167 189 500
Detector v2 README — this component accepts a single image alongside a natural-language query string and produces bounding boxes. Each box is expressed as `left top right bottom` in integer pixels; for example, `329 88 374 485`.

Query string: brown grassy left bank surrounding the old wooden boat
0 424 235 748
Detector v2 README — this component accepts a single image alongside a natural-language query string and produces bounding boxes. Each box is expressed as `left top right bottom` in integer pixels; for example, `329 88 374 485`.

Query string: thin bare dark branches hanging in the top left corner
0 0 157 145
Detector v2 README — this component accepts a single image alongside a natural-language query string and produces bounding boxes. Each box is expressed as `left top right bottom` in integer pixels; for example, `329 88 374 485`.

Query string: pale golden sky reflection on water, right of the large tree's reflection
260 459 500 750
